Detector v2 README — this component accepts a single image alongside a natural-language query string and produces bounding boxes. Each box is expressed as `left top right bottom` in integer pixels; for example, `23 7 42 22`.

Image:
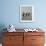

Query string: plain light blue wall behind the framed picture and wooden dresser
0 0 46 28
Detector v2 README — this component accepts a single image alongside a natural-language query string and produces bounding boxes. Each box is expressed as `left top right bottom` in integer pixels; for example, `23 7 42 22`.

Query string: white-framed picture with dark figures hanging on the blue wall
20 5 34 22
